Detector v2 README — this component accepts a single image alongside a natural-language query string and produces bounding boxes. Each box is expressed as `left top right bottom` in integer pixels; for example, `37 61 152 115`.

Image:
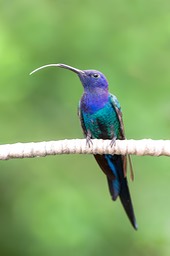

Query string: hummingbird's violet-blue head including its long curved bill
30 64 108 92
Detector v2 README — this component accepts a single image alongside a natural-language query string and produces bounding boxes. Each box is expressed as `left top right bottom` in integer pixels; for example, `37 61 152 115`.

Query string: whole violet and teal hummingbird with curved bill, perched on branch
30 64 138 230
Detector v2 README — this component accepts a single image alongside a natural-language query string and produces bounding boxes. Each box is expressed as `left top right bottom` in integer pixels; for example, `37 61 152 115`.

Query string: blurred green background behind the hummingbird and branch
0 0 170 256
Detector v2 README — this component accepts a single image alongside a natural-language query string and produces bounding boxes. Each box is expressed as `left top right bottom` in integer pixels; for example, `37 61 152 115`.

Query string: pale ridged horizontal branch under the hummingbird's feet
0 139 170 160
